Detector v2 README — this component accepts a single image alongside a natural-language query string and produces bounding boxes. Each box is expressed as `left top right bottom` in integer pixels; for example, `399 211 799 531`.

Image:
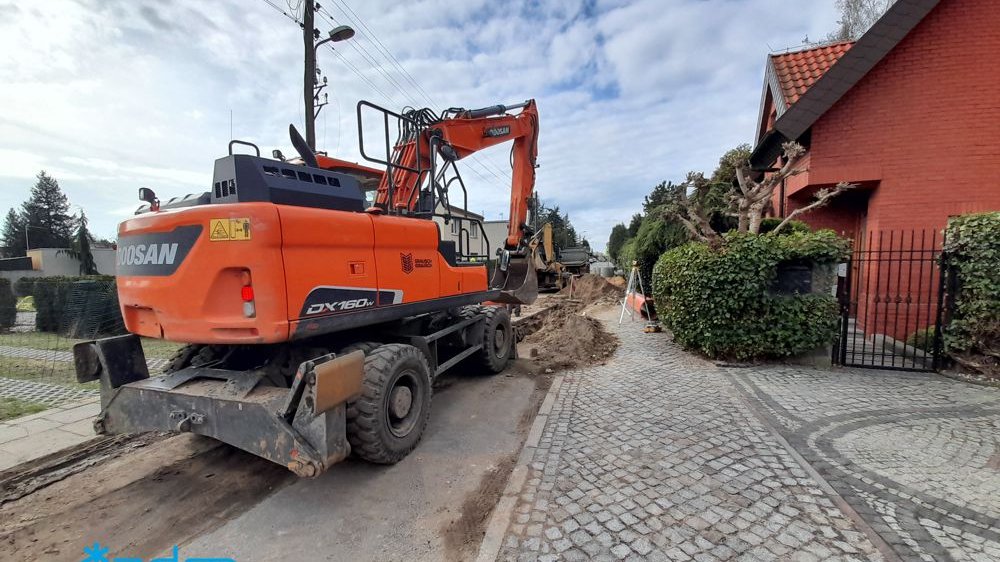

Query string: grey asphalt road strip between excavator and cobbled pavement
181 366 542 562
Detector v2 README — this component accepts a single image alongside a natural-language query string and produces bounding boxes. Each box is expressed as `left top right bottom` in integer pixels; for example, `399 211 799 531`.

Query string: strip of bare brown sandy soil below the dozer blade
0 435 294 560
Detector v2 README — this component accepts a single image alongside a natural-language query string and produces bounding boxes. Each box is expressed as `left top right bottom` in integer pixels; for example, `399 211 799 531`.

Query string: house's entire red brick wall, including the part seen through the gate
768 0 1000 339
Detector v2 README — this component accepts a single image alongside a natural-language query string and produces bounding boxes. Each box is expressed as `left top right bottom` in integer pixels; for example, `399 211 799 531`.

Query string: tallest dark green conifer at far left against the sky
21 170 73 248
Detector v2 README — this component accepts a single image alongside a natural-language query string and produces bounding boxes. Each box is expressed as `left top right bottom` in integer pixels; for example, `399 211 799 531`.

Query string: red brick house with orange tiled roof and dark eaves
751 0 1000 354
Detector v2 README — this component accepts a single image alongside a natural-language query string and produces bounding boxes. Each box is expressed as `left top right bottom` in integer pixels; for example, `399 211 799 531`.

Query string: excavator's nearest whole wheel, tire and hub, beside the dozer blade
347 343 431 464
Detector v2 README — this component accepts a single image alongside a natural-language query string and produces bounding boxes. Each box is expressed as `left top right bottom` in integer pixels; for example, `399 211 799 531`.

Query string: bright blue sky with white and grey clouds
0 0 837 248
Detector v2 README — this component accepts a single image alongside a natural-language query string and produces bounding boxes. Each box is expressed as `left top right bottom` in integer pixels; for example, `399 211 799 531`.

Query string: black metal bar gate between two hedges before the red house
834 230 945 371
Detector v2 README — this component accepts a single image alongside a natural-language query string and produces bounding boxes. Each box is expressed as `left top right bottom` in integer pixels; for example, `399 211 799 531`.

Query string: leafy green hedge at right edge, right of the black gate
944 212 1000 375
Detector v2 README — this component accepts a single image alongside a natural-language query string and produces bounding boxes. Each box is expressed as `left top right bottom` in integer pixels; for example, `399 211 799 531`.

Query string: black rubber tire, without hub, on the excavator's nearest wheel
347 343 431 464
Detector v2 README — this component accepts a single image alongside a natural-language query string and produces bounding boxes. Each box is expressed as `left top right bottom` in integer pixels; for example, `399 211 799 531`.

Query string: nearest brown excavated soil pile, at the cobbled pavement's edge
518 303 618 373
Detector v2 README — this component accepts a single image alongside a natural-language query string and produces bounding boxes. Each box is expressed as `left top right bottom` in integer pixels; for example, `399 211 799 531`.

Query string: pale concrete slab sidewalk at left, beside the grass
0 397 101 470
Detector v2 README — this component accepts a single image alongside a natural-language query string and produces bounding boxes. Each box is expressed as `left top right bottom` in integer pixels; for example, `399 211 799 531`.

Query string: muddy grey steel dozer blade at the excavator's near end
73 335 364 477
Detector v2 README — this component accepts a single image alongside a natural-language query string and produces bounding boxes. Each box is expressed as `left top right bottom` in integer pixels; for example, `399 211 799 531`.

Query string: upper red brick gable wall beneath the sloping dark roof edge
807 0 1000 234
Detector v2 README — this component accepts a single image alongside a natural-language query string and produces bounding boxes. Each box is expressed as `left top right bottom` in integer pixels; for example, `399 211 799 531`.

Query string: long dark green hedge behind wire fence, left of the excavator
31 275 125 338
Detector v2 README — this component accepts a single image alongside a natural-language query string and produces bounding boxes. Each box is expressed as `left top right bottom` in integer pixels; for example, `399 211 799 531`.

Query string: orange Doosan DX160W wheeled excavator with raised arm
74 100 538 476
